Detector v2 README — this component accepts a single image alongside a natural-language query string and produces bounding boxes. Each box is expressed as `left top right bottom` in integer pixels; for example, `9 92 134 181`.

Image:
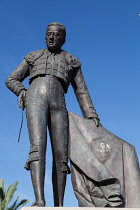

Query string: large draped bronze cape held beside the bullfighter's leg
69 112 140 208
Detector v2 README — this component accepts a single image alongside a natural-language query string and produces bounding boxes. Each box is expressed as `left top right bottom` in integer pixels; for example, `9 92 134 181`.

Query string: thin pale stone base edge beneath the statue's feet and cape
20 207 140 210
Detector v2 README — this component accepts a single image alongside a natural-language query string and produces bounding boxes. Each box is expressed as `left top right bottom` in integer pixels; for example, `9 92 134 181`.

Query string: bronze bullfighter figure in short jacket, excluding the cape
6 22 99 206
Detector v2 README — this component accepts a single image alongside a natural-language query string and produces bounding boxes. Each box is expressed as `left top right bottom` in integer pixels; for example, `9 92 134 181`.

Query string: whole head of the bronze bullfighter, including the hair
45 22 66 51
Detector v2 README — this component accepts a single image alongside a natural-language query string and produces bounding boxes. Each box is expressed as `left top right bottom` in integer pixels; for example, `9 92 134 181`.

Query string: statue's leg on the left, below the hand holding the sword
26 81 47 206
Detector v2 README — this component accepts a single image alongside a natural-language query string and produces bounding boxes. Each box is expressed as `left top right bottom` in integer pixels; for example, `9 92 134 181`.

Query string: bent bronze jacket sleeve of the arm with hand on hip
6 59 29 96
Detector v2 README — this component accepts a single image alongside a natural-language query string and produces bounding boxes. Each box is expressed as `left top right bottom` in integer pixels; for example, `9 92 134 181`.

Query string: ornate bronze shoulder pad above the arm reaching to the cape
65 51 81 68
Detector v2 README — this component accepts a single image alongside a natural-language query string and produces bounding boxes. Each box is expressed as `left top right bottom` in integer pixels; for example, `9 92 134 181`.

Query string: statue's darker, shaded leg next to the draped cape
49 80 68 206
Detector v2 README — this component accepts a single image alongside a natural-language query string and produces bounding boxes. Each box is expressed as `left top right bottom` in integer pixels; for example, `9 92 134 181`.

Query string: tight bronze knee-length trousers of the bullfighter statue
25 75 69 172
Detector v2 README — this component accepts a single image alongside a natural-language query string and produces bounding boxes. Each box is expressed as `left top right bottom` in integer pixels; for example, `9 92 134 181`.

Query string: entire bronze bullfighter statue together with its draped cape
6 22 140 207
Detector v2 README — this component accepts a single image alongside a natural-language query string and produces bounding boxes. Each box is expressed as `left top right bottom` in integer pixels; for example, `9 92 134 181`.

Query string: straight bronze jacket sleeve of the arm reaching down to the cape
71 67 99 119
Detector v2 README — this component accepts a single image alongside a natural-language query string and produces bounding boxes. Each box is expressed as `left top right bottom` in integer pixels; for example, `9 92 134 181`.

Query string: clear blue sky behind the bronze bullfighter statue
0 0 140 206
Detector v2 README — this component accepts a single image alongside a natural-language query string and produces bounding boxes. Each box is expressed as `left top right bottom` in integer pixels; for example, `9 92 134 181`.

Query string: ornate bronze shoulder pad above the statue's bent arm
24 49 45 63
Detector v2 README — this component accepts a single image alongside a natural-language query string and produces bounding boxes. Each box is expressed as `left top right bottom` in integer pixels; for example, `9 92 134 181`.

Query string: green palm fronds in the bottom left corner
0 179 29 210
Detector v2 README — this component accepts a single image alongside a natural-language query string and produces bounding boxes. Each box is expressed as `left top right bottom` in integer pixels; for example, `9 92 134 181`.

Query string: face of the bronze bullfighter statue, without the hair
46 26 64 50
